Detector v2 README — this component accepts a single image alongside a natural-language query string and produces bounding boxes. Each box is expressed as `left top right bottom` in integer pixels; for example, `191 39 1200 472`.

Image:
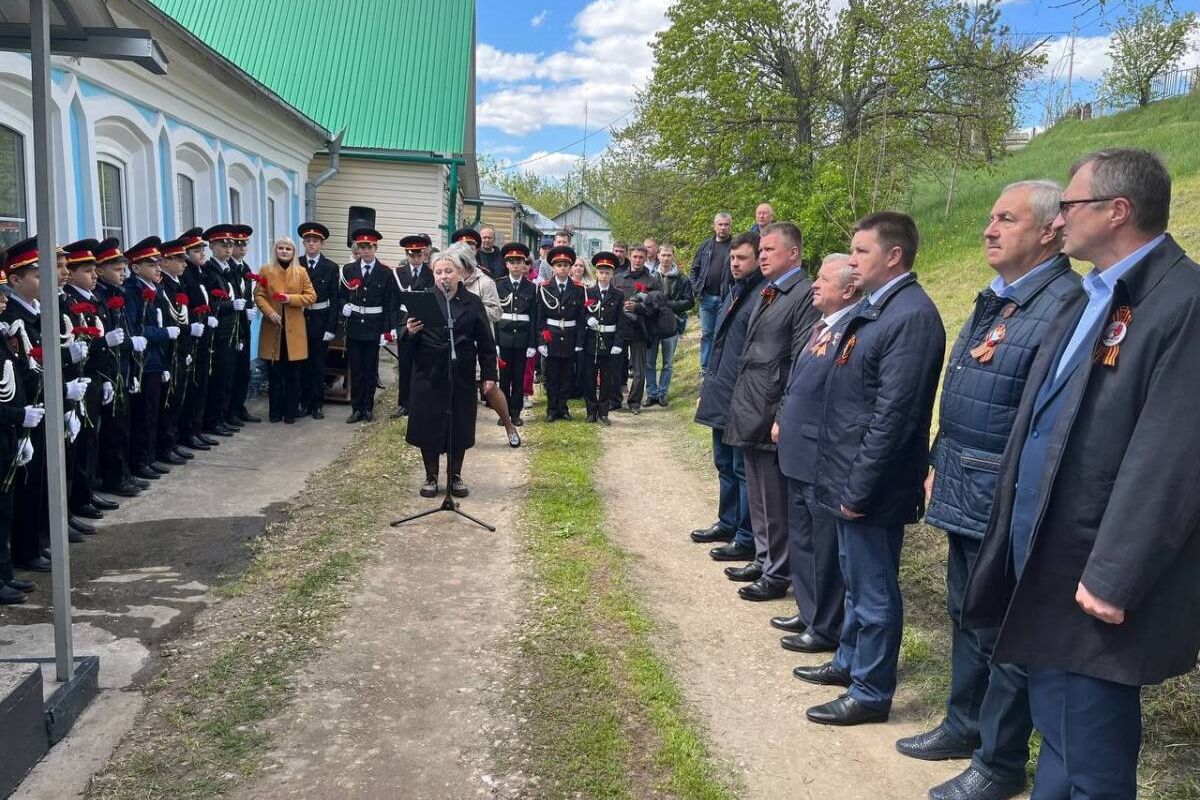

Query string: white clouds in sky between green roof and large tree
476 0 672 136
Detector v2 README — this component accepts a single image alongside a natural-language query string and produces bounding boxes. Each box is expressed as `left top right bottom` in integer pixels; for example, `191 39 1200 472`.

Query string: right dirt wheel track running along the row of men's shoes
602 411 965 800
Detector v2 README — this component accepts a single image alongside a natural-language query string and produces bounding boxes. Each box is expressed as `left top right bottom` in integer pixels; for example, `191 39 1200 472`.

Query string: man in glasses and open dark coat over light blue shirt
962 149 1200 799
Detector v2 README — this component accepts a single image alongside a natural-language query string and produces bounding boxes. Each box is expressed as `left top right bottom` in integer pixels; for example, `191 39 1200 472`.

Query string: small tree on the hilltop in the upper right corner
1104 2 1198 106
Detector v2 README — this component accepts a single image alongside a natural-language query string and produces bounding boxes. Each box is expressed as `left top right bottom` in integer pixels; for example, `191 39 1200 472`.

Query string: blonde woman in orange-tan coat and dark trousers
254 237 317 425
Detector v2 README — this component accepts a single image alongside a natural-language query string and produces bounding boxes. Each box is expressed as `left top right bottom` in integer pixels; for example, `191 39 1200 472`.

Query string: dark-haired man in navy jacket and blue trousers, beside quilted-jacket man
792 211 946 724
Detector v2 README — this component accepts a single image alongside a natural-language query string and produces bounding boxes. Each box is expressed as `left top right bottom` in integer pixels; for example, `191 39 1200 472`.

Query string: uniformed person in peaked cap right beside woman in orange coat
296 222 341 420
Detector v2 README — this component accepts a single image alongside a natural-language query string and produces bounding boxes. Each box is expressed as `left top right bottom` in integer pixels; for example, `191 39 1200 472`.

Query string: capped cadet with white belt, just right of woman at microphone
496 242 538 426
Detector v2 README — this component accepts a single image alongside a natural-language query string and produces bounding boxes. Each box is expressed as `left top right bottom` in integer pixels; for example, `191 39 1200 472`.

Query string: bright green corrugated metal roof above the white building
150 0 475 154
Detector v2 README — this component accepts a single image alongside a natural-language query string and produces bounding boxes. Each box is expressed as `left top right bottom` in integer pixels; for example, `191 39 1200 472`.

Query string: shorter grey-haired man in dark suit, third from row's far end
770 253 862 652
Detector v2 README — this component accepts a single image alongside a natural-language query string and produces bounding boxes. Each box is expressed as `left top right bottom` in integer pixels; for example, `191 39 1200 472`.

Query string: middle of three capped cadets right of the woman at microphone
538 246 583 422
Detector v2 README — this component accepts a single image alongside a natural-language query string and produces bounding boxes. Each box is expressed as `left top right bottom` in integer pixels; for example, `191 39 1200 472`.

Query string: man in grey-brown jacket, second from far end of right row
725 222 820 601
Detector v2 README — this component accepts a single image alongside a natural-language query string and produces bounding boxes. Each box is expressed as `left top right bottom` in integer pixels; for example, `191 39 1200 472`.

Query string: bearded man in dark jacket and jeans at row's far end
691 234 763 561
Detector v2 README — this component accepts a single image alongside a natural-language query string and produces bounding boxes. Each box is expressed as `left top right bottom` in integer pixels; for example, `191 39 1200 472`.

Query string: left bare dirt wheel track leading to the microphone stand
235 417 528 800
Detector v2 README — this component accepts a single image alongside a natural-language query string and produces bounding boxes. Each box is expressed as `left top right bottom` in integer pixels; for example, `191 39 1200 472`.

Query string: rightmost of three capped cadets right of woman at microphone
583 251 625 427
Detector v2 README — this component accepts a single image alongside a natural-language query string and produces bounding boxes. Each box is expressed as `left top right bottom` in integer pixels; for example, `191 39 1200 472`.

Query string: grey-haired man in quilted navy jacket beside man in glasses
896 181 1080 800
